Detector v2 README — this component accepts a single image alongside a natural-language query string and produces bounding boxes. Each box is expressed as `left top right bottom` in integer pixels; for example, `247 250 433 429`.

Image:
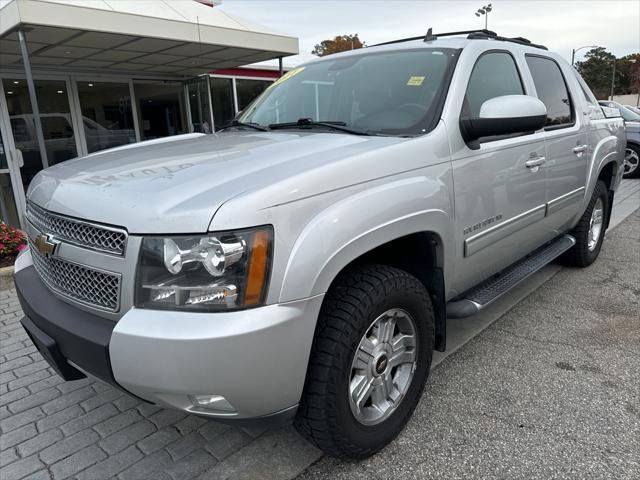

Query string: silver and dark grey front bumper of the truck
15 258 323 420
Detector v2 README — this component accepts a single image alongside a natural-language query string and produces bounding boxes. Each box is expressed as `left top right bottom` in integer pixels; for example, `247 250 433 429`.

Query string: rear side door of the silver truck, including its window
525 54 590 233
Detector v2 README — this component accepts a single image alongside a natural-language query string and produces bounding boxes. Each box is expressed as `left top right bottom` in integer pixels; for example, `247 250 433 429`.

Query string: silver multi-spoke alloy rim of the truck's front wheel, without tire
348 308 418 425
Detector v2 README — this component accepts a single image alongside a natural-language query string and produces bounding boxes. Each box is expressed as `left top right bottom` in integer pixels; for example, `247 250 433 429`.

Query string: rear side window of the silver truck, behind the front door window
526 55 574 127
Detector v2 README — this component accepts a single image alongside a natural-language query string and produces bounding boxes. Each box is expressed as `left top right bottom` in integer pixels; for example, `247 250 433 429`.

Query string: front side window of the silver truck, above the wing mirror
462 52 524 118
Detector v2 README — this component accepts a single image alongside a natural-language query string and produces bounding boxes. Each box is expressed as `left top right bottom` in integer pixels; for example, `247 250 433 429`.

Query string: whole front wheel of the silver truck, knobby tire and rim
296 265 434 459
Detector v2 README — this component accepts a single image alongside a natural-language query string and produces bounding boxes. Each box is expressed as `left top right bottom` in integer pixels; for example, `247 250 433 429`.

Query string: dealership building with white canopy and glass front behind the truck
0 0 298 226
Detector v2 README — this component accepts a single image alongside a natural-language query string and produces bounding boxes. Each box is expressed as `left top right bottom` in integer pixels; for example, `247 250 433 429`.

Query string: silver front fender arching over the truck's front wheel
280 167 455 302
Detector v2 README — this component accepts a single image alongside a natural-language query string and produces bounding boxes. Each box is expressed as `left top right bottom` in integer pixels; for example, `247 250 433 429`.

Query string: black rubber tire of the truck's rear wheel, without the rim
562 180 609 268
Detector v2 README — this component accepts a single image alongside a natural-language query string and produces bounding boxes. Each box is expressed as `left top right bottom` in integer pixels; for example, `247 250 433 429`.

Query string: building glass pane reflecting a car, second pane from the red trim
77 82 136 153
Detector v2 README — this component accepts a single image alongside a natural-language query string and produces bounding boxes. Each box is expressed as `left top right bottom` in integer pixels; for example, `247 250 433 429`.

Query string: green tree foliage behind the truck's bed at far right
576 47 640 99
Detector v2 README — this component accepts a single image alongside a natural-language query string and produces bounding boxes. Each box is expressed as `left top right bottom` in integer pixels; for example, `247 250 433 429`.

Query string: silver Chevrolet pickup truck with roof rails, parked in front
15 31 625 458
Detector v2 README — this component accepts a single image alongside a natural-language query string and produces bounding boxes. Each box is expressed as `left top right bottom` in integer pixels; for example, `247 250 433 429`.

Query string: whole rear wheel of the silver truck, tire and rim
563 180 609 267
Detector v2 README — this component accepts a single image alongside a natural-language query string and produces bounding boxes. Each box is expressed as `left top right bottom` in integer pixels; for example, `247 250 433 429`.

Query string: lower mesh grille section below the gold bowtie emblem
29 240 120 312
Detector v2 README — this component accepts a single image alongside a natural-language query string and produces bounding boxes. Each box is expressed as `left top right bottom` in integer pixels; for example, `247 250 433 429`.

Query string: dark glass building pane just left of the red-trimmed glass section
134 81 187 140
